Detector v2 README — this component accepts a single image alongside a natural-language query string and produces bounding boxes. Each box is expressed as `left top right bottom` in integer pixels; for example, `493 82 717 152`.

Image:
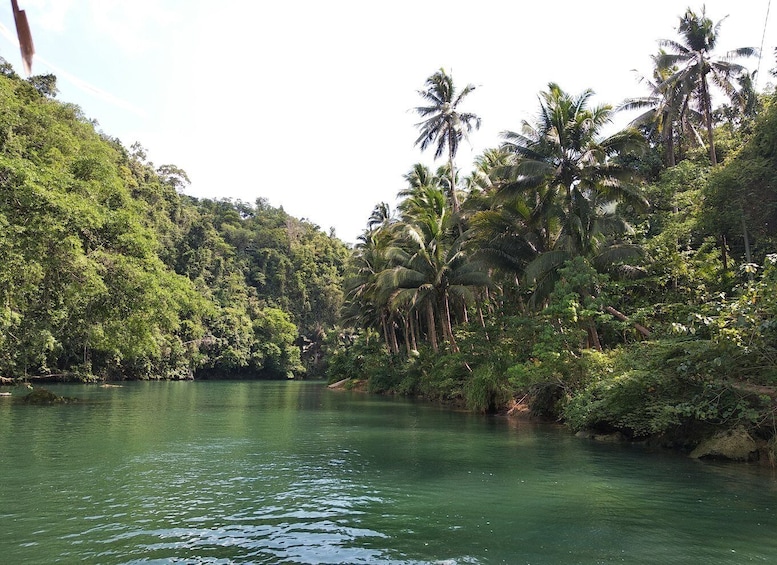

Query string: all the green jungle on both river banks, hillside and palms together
0 4 777 452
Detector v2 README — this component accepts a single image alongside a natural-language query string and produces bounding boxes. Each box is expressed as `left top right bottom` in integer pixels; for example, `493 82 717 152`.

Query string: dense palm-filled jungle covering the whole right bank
328 9 777 452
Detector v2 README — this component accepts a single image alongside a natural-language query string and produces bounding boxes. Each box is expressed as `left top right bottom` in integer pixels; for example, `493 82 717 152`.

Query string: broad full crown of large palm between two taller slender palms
500 83 645 251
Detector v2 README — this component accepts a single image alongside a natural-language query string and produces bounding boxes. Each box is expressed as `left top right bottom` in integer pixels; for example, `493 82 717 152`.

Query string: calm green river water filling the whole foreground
0 381 777 565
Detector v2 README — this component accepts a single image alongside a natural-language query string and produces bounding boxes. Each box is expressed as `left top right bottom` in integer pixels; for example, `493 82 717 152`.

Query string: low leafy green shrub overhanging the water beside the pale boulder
563 340 766 438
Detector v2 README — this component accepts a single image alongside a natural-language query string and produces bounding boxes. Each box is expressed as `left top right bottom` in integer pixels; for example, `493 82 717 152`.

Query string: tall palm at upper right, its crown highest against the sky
657 7 757 166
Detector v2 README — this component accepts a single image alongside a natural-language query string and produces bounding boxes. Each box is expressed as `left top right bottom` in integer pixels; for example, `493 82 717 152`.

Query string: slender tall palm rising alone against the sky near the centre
415 69 480 216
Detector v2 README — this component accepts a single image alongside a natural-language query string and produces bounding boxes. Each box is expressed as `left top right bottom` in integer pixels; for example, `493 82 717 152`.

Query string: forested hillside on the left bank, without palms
0 68 348 379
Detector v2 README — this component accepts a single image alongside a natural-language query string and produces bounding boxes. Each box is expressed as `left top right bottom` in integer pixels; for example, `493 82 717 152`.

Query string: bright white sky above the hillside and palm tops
0 0 777 242
